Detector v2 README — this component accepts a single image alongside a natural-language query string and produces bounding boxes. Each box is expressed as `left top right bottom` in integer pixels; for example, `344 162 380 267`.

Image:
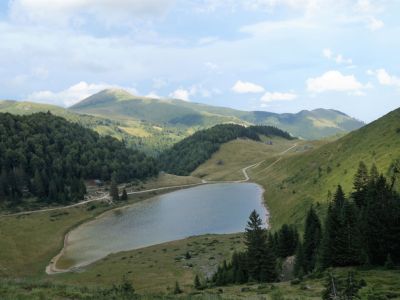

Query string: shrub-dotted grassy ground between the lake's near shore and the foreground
51 234 244 293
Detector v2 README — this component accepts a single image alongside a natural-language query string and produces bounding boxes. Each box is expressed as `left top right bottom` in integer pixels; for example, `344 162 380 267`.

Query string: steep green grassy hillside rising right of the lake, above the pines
249 109 400 226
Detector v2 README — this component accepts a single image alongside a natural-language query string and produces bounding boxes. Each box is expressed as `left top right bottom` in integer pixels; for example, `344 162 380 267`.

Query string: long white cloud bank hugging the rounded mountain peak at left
27 81 137 106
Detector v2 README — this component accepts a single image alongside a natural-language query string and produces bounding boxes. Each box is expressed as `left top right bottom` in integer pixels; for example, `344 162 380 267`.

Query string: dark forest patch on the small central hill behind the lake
160 124 292 175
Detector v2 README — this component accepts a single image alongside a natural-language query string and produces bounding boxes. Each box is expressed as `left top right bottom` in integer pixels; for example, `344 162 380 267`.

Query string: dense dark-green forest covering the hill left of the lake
0 113 158 204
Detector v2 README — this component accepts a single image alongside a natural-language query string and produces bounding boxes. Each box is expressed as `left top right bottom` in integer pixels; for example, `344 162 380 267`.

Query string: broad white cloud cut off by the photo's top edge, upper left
10 0 175 24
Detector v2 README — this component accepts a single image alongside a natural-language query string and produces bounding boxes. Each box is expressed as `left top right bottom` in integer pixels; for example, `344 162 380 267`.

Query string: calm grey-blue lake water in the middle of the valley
57 183 267 267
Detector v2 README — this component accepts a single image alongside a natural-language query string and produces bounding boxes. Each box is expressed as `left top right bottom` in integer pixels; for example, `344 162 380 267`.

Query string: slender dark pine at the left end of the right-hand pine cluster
302 206 322 274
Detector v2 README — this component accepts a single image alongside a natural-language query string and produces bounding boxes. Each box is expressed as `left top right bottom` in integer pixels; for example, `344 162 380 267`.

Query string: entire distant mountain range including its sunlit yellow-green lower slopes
0 89 364 154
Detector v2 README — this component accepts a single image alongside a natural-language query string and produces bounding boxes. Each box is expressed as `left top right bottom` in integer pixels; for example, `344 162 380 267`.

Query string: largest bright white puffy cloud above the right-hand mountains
307 71 368 93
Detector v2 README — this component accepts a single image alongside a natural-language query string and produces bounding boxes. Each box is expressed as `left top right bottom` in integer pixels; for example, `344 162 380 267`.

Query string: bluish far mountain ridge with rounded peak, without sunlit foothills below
70 89 364 139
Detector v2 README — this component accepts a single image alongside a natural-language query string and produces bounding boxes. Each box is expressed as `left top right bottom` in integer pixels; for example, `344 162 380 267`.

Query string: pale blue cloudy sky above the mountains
0 0 400 122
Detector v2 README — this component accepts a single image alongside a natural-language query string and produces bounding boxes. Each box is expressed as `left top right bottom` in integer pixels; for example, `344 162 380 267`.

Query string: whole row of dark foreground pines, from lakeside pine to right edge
212 162 400 285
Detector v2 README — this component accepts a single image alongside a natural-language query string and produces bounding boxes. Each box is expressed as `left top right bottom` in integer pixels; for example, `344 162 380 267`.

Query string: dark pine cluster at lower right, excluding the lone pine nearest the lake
296 162 400 274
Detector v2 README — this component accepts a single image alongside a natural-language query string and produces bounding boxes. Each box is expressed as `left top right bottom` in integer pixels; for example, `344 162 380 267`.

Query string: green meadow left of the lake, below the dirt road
0 174 203 277
